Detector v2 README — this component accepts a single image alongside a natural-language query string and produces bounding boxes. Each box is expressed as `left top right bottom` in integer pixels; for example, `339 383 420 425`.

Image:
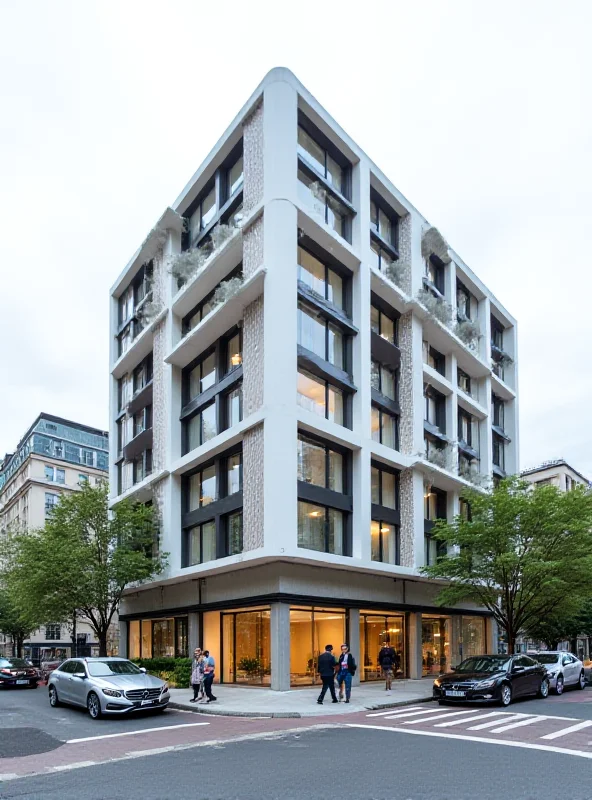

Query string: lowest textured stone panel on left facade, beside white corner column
243 425 263 551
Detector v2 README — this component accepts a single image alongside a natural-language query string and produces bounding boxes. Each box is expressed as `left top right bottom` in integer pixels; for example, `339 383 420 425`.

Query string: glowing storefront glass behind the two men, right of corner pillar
290 607 346 686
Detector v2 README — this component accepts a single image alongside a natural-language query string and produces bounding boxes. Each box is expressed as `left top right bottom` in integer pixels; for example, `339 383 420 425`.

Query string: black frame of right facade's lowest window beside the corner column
297 429 353 557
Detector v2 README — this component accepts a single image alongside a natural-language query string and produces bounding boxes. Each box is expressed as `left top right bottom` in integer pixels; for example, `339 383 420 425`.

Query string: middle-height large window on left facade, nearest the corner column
181 329 243 453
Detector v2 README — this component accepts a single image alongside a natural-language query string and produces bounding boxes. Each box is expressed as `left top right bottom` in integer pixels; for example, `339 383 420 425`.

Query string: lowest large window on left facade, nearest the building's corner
182 450 243 566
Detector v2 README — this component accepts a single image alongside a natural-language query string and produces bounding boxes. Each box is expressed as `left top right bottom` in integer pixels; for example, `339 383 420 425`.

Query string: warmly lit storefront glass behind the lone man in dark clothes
360 611 406 681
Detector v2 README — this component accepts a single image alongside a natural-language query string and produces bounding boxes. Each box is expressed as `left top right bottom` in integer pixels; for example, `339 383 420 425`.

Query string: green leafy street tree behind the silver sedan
5 483 165 655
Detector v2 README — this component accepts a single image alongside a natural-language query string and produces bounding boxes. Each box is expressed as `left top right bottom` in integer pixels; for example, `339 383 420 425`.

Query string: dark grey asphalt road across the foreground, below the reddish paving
0 728 592 800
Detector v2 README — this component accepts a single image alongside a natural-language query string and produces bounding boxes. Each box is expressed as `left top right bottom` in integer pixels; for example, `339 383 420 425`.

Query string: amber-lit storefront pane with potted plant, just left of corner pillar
222 608 271 686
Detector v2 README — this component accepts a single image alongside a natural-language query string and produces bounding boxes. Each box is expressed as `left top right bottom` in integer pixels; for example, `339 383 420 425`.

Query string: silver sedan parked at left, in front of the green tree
47 658 170 719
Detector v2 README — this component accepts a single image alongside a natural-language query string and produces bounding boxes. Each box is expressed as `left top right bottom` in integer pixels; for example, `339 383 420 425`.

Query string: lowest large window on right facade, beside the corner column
297 434 352 555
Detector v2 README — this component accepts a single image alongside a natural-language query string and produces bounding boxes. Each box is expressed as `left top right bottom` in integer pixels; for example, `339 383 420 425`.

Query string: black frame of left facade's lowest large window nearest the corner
181 442 244 568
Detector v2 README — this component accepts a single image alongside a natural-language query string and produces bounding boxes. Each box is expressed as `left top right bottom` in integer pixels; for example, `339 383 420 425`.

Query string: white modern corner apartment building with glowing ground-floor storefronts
110 69 518 689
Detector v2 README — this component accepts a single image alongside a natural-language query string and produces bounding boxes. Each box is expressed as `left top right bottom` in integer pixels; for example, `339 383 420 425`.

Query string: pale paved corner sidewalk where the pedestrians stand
170 678 434 718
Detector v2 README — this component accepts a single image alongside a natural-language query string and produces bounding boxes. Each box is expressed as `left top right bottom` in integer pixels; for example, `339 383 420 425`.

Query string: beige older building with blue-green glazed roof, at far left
0 414 109 662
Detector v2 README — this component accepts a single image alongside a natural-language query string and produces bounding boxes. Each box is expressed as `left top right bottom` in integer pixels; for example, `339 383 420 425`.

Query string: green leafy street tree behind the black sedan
423 477 592 652
